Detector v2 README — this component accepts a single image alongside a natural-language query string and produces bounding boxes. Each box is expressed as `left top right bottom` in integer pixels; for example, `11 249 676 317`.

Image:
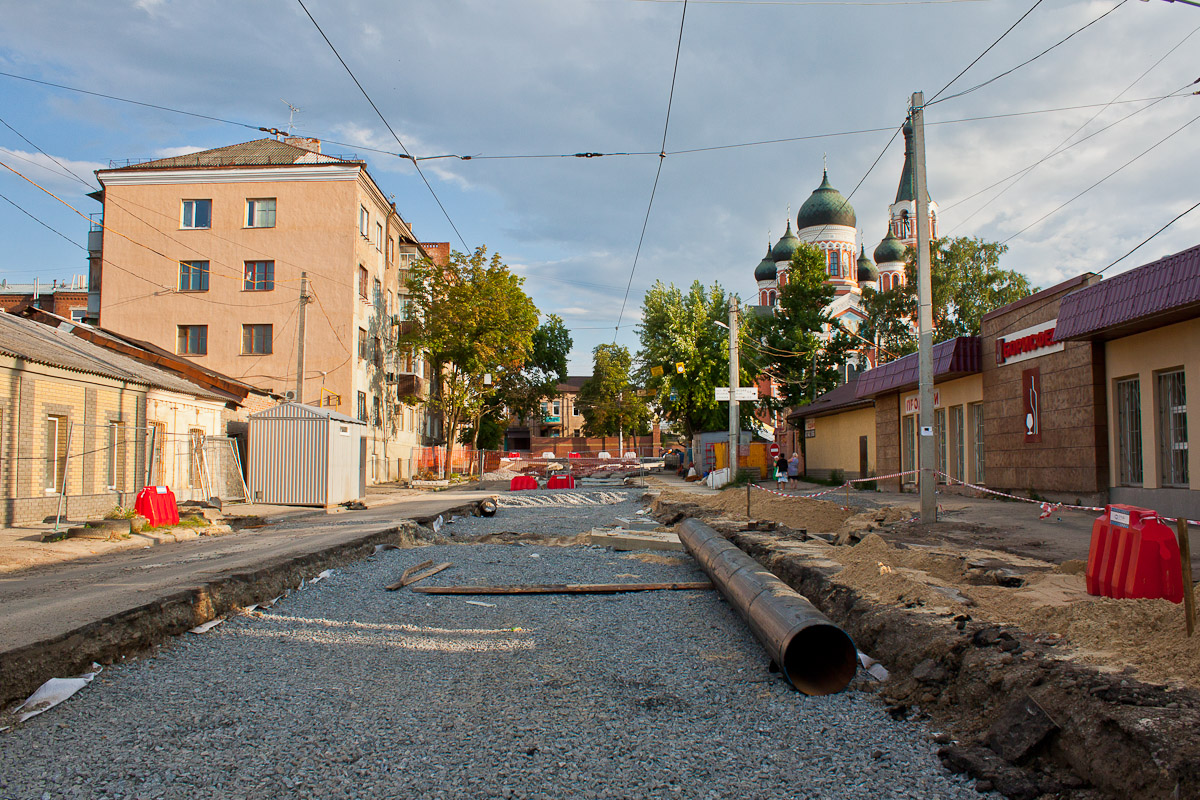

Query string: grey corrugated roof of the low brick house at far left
0 313 238 402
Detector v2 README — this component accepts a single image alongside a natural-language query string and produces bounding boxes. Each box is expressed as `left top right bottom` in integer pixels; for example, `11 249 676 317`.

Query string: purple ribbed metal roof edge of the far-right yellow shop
1055 245 1200 341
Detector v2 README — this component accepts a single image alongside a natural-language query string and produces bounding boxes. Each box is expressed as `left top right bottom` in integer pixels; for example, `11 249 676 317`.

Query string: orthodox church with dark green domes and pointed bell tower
754 125 937 366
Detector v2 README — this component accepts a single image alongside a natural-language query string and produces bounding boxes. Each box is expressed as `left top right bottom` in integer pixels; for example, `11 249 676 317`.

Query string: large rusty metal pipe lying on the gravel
679 519 858 694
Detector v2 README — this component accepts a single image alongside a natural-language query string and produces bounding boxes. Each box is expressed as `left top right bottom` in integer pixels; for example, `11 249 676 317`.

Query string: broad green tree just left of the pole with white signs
637 281 754 440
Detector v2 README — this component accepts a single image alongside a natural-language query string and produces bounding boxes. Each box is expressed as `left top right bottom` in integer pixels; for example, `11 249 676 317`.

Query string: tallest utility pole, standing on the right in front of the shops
908 91 937 523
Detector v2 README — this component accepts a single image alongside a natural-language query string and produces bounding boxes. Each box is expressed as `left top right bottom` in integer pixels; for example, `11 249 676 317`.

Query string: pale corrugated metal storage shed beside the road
250 403 366 506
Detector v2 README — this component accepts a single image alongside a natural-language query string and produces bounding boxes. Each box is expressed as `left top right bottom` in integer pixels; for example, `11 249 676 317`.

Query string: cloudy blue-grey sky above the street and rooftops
0 0 1200 374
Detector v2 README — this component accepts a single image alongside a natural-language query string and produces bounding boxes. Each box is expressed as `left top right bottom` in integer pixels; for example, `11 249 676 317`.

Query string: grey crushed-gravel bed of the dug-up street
0 493 993 800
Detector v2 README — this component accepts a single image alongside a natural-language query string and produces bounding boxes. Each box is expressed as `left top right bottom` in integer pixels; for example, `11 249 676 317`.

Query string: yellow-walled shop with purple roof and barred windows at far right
1055 246 1200 519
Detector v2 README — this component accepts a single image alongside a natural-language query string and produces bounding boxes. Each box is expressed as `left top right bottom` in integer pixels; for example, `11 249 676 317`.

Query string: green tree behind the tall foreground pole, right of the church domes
858 231 1038 360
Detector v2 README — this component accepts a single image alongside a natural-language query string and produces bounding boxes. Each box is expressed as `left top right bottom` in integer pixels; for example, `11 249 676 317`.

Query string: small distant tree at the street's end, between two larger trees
575 344 650 437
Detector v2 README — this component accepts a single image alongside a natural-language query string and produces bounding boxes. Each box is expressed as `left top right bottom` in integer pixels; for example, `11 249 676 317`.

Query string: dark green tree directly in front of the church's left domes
746 243 858 410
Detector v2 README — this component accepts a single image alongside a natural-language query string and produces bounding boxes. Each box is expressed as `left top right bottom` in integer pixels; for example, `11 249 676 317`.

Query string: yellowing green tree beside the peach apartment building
397 246 538 474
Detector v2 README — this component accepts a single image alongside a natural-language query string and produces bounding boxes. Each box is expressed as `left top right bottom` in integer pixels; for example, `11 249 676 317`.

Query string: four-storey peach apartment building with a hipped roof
89 138 438 482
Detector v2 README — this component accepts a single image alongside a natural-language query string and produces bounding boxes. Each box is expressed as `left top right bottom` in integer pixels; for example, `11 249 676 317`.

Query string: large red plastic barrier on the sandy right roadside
1086 505 1183 603
